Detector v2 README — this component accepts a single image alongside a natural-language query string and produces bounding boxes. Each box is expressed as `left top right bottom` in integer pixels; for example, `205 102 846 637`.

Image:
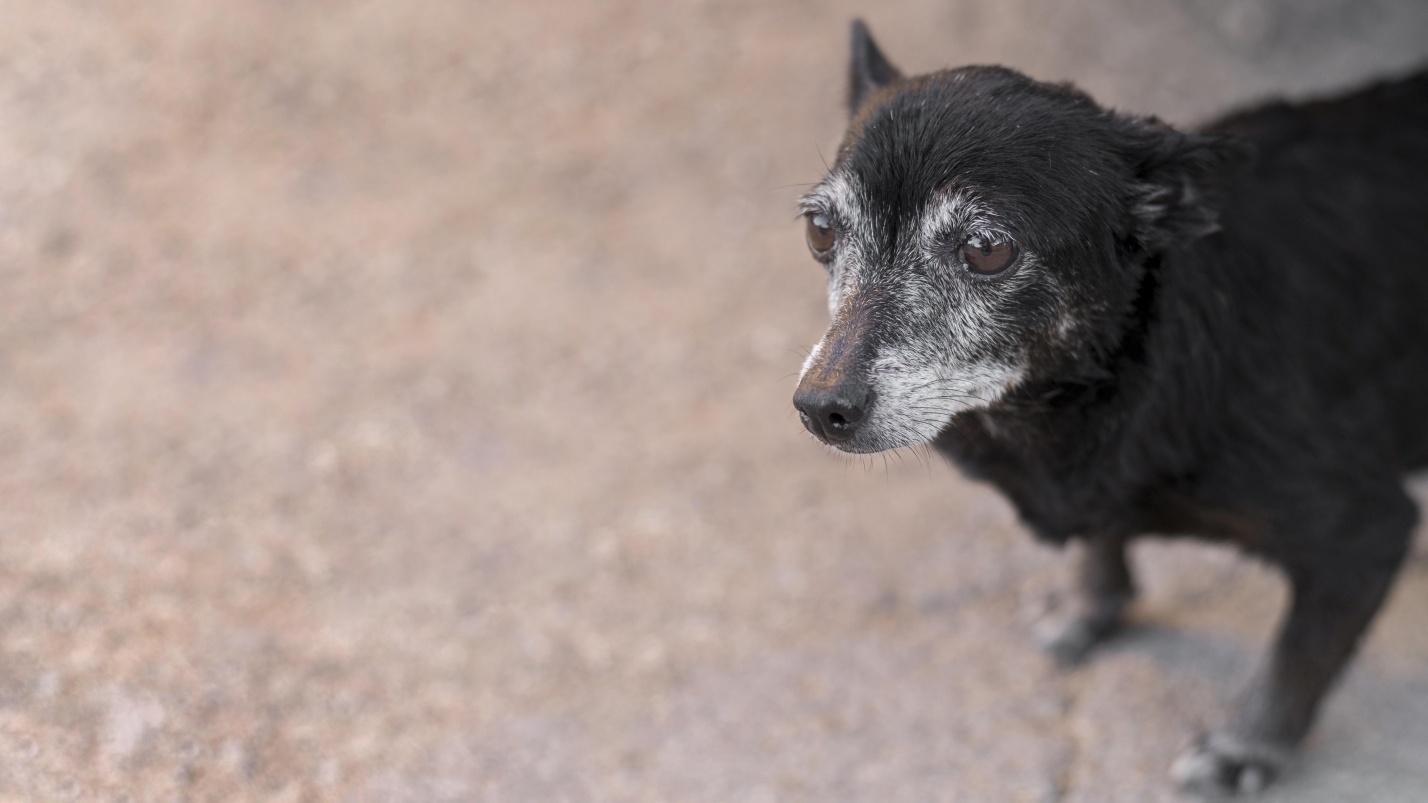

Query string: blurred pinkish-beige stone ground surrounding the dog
0 0 1428 803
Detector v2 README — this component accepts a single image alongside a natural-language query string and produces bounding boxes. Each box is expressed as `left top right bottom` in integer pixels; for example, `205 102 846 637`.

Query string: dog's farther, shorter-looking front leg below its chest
1037 534 1135 666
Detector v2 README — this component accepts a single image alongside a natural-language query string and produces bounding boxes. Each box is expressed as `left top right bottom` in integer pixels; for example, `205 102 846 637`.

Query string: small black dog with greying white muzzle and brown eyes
794 23 1428 793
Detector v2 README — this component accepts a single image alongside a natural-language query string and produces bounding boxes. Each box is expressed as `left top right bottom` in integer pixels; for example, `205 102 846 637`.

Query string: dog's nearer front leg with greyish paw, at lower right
1172 489 1417 796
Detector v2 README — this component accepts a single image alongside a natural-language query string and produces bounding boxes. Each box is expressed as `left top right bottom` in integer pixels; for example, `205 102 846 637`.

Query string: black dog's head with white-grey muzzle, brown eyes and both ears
794 21 1238 453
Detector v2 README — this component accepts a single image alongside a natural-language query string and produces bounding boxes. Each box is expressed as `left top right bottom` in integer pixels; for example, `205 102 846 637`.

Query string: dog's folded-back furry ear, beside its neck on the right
1125 117 1252 247
